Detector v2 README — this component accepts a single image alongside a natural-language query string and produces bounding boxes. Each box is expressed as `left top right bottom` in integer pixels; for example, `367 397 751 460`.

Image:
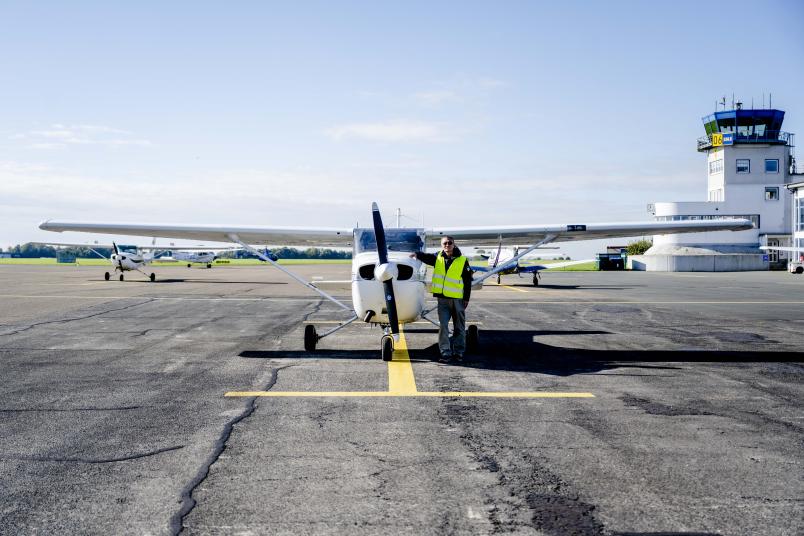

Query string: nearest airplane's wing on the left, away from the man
39 220 353 249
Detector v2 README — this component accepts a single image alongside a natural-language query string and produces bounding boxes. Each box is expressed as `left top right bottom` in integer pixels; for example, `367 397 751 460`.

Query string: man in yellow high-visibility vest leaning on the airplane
410 236 472 363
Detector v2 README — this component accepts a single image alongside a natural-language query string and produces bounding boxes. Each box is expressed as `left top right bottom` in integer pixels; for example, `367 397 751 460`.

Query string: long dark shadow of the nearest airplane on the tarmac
239 329 804 376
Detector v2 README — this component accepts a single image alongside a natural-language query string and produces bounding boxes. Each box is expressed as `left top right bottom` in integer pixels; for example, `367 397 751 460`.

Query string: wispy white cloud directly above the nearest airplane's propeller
326 119 453 143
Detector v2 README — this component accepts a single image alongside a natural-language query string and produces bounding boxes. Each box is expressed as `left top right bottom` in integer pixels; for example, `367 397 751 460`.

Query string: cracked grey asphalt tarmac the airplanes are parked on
0 265 804 536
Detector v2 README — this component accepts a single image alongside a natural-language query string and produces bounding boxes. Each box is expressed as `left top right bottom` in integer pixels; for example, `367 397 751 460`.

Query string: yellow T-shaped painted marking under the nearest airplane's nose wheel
224 329 595 398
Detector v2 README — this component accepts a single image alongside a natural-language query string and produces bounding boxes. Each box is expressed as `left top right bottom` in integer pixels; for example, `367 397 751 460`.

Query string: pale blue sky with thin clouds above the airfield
0 1 804 255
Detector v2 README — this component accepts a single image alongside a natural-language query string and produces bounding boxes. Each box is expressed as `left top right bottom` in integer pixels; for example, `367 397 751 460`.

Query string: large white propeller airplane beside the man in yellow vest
39 203 752 361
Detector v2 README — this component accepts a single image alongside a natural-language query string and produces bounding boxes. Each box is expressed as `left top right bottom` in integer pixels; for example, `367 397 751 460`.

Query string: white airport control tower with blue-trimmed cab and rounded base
632 102 800 272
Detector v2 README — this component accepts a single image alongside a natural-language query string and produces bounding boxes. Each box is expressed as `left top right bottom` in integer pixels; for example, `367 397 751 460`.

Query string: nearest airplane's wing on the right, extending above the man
434 219 753 246
